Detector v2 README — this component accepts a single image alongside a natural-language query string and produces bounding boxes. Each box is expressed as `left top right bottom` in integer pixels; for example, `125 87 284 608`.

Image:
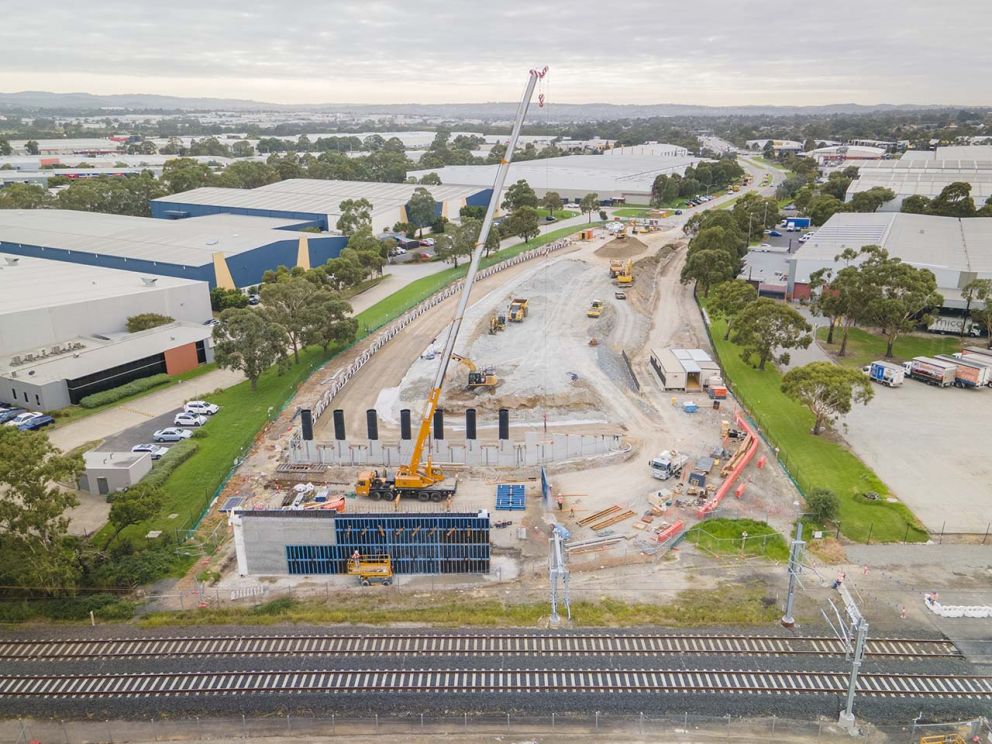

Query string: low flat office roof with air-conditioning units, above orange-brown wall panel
0 321 213 385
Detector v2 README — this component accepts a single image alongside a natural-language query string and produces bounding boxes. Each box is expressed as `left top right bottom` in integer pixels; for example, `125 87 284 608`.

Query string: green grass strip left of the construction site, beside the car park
94 347 334 545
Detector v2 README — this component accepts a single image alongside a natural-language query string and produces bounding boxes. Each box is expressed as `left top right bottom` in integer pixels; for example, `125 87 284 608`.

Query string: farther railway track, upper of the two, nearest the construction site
0 634 961 661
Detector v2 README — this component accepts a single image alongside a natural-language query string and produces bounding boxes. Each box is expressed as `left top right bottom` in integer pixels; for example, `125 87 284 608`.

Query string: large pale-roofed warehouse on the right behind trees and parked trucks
779 212 992 309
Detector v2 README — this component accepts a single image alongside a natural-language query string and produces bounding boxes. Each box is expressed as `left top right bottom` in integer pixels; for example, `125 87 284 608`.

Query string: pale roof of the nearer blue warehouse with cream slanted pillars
0 209 310 266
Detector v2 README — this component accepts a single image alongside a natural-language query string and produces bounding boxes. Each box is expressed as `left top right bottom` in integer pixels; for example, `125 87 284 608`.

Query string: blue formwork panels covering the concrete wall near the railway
286 512 490 575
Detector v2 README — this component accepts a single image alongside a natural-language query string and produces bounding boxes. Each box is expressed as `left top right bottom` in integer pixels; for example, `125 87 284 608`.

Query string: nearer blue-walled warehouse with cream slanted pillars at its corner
0 209 347 289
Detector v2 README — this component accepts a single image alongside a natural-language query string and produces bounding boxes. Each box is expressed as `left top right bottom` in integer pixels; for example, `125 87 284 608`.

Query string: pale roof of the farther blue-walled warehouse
154 179 492 215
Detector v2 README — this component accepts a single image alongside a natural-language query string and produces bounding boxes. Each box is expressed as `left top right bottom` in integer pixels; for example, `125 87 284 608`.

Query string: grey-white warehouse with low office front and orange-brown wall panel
0 255 213 410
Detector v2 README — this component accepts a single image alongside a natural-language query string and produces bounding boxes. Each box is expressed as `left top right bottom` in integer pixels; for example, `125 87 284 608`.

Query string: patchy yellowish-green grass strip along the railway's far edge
139 583 780 628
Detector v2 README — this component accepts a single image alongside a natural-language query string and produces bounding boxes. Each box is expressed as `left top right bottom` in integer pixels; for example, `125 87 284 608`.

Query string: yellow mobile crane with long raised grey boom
355 67 548 502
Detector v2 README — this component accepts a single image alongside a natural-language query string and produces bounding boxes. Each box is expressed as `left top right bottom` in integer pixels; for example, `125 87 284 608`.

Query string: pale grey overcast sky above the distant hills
0 0 992 105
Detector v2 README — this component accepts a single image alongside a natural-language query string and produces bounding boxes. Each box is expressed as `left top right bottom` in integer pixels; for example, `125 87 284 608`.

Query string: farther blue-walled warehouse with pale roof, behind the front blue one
151 178 491 231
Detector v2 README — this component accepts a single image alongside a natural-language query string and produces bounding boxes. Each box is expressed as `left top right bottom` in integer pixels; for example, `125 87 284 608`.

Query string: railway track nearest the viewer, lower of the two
0 669 992 700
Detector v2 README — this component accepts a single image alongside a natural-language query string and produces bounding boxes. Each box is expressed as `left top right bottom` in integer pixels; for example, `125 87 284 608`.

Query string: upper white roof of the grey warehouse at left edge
0 255 206 315
